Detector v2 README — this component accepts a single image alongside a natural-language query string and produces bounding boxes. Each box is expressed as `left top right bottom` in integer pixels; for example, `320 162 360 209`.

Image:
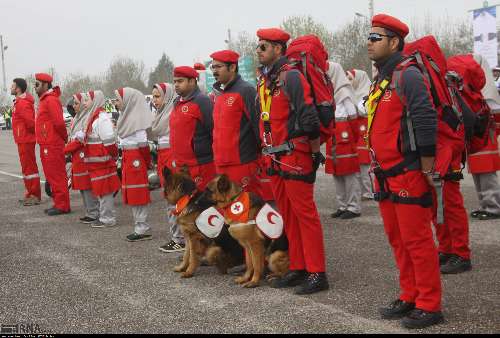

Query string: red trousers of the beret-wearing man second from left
40 144 71 212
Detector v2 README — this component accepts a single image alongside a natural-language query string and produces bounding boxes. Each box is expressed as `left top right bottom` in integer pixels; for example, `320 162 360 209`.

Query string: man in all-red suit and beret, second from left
35 73 71 216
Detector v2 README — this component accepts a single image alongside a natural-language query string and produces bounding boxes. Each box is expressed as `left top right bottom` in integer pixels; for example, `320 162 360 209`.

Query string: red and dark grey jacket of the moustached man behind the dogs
213 75 260 167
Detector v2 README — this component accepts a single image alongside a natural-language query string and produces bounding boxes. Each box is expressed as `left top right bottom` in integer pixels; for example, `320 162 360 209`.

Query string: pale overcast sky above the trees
0 0 486 83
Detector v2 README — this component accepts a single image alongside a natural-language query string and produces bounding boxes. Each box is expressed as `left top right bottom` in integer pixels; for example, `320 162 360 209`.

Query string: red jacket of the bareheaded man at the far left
12 93 36 144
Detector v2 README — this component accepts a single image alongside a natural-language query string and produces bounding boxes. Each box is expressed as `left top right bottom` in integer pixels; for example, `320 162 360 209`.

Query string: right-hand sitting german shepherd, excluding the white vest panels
207 175 290 288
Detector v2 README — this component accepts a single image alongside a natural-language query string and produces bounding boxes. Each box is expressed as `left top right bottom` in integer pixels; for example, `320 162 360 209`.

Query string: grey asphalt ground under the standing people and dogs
0 131 500 333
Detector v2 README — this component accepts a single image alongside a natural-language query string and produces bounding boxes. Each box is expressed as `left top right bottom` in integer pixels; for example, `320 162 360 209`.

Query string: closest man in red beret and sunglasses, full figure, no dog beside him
366 14 443 329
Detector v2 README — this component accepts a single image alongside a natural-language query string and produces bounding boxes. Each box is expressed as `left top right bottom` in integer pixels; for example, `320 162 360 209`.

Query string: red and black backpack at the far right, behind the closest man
447 54 494 154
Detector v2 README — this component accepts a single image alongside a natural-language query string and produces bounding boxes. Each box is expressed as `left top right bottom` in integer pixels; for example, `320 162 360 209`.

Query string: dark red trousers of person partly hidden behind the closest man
436 181 471 259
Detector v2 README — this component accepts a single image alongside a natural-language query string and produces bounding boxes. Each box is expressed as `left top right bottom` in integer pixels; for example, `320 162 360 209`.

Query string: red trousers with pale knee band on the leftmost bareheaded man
17 143 42 199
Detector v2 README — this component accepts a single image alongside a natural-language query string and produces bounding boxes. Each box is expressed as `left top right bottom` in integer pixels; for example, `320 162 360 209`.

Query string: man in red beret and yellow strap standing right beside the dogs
257 28 329 295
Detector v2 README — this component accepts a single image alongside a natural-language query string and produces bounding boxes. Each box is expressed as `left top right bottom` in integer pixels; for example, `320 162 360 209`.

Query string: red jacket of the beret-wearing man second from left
35 87 68 147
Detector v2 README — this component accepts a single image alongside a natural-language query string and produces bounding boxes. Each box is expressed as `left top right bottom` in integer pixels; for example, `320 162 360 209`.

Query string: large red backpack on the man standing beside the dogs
286 35 335 142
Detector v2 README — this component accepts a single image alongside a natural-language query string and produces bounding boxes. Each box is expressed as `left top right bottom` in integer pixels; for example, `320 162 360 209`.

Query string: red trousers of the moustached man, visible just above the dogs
215 162 263 197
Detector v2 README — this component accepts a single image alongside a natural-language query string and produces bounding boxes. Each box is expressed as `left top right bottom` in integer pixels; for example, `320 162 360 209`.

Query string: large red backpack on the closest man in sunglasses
394 36 465 177
